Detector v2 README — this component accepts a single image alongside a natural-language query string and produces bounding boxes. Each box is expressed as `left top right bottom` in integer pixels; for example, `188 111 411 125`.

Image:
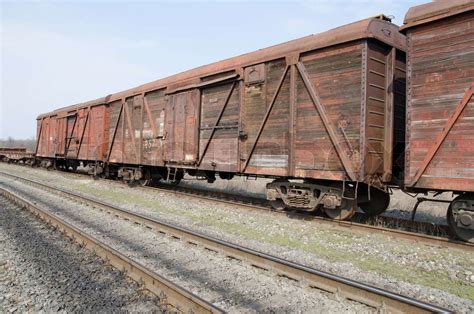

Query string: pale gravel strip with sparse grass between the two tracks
0 165 474 312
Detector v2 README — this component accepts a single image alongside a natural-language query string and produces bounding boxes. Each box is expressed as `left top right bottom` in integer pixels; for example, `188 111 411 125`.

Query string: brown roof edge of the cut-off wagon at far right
400 0 474 30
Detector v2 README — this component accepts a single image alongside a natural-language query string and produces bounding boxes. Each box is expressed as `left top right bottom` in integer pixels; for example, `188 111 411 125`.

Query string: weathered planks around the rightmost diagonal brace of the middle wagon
295 42 363 180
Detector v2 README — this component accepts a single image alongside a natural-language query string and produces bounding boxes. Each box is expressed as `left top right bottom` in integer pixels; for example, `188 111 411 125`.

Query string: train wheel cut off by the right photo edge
446 194 474 243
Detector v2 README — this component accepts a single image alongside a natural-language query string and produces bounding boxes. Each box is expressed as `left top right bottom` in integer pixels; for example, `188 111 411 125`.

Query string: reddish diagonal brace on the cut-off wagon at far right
409 82 474 187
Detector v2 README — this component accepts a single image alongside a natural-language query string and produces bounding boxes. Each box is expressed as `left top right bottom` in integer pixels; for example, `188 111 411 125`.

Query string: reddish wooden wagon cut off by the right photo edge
402 0 474 241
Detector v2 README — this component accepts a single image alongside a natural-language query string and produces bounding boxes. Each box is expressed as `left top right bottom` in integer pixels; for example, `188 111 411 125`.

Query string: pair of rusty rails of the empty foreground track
0 173 448 312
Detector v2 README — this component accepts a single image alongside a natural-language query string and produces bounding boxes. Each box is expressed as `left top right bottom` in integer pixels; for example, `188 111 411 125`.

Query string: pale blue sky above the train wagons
0 0 428 138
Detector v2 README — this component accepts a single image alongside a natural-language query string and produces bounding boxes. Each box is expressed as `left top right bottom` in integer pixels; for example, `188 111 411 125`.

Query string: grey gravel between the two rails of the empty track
2 177 373 313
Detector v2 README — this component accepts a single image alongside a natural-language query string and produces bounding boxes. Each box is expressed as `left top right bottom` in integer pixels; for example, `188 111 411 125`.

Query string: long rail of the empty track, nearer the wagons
0 172 450 313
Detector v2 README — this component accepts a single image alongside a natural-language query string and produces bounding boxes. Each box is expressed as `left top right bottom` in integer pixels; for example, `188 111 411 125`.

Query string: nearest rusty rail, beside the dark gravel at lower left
0 187 223 313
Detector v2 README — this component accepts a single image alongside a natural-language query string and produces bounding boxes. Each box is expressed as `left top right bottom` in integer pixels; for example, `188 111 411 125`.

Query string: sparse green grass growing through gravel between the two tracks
5 164 474 301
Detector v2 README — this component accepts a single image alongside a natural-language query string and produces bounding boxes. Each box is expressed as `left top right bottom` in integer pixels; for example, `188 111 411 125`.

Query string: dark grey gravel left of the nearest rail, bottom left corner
0 197 161 313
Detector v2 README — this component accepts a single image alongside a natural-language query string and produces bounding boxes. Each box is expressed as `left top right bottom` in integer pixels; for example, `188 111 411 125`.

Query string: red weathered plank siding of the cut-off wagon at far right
405 10 474 192
